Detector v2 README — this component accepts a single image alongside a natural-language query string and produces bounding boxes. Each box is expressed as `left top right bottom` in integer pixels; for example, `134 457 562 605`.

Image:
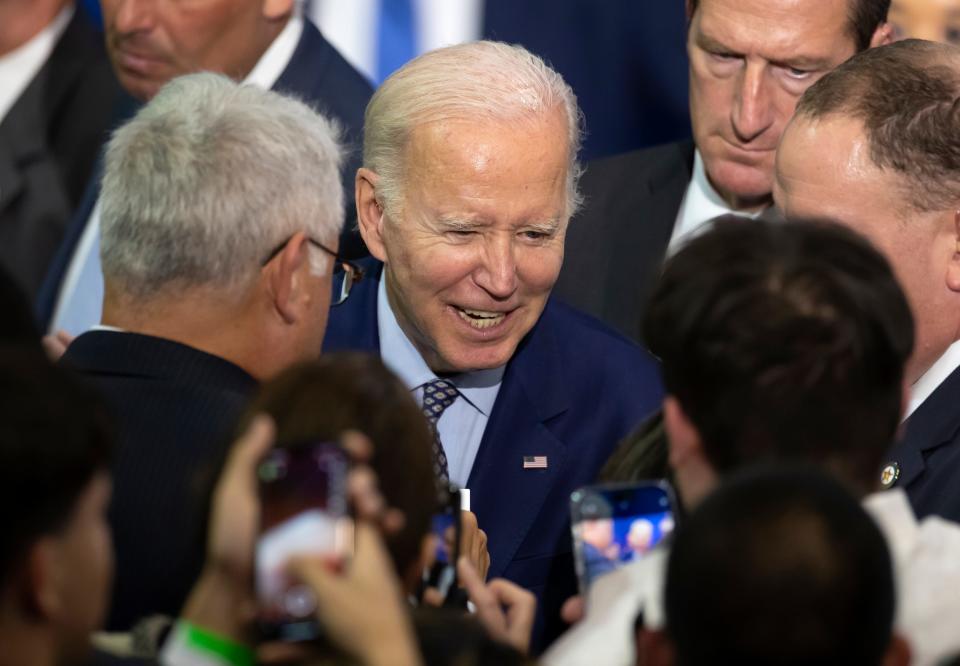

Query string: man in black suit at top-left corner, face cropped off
0 0 120 300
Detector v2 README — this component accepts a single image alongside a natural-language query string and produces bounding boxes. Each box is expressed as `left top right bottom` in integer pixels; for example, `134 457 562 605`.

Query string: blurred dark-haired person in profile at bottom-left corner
0 346 113 666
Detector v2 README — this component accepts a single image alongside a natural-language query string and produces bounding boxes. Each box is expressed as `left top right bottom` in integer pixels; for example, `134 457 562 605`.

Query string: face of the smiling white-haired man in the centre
380 111 569 372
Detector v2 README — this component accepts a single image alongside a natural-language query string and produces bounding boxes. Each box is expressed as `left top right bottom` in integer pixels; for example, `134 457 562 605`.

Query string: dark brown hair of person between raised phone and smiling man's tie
243 353 437 578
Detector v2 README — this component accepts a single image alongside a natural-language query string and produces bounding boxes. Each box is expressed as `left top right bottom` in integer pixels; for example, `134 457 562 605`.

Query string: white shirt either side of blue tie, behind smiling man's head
308 0 483 81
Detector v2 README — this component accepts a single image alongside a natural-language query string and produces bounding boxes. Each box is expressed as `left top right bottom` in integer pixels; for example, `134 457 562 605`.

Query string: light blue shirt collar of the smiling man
377 270 505 416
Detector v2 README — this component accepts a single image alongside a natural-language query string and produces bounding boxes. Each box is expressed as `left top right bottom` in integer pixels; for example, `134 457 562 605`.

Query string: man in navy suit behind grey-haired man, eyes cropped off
38 0 372 335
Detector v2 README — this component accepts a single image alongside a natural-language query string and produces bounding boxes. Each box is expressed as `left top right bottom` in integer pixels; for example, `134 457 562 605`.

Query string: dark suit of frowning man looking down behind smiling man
554 141 694 341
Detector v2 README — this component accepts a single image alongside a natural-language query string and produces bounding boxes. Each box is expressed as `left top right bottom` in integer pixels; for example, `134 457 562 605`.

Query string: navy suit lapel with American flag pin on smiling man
467 305 570 577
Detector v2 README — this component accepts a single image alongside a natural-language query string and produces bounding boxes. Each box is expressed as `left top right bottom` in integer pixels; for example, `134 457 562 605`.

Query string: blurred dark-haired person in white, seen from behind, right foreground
545 220 960 664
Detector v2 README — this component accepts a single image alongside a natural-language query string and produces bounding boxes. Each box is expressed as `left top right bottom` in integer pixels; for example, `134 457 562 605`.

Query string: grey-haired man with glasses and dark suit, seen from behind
62 74 345 629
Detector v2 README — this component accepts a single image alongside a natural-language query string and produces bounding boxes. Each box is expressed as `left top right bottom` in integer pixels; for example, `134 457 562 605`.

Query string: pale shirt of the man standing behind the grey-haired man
49 13 303 335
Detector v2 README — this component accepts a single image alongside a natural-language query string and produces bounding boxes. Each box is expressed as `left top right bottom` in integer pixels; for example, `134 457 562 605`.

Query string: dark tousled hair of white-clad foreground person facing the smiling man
644 219 913 492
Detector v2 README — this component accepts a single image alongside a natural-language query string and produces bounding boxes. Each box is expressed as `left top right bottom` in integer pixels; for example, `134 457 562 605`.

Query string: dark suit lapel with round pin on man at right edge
890 368 960 488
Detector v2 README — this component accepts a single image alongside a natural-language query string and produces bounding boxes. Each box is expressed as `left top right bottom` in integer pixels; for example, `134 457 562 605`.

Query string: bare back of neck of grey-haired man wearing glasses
101 286 284 381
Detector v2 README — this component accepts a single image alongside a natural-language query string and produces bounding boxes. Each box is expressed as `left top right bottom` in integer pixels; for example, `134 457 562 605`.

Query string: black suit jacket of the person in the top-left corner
0 7 119 300
